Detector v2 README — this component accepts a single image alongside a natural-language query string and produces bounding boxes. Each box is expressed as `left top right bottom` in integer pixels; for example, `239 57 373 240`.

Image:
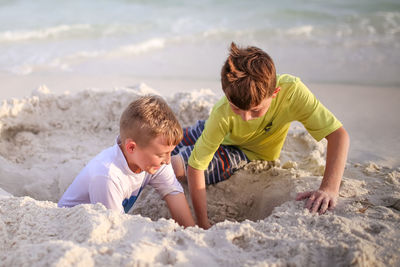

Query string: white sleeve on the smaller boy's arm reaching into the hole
149 164 183 198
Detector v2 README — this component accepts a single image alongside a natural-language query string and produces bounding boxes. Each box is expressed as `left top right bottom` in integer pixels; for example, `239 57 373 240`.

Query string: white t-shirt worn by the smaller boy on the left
58 140 183 213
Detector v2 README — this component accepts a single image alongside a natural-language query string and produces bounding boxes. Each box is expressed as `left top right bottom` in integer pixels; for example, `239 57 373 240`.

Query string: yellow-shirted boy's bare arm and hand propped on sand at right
296 127 350 214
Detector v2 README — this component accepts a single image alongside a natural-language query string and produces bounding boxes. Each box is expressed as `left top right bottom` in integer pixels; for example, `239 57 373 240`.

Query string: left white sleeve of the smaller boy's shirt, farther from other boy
89 176 124 213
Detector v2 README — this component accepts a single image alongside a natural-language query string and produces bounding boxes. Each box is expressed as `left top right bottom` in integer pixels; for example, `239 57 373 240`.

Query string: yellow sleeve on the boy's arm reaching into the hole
188 104 229 170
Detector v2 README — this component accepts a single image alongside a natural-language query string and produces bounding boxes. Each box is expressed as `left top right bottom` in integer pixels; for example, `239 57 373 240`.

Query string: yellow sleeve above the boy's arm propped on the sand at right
289 81 342 141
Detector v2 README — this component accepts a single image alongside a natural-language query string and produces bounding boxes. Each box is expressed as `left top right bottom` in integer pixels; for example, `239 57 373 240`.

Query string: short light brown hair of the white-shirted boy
119 95 183 146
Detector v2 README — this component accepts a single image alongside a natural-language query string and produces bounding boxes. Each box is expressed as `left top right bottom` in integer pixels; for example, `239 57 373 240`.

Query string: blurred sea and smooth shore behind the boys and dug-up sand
0 0 400 166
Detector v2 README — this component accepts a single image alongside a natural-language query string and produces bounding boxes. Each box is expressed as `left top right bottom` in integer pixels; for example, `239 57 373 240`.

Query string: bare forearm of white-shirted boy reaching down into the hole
164 193 195 227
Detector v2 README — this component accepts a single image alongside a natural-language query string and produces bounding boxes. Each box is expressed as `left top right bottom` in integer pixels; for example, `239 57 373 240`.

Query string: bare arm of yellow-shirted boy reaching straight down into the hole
187 165 211 229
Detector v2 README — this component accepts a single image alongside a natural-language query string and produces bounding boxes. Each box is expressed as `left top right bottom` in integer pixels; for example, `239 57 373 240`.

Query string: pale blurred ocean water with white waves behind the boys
0 0 400 94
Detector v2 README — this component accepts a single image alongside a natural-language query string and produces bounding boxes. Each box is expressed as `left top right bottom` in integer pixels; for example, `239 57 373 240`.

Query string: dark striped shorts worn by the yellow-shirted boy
171 120 250 184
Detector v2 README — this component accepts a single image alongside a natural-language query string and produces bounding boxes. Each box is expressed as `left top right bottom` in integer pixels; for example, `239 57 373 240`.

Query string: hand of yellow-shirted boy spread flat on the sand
296 190 337 214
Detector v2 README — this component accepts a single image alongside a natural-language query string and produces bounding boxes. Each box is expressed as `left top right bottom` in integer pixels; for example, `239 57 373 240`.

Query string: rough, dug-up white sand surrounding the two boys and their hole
0 85 400 266
